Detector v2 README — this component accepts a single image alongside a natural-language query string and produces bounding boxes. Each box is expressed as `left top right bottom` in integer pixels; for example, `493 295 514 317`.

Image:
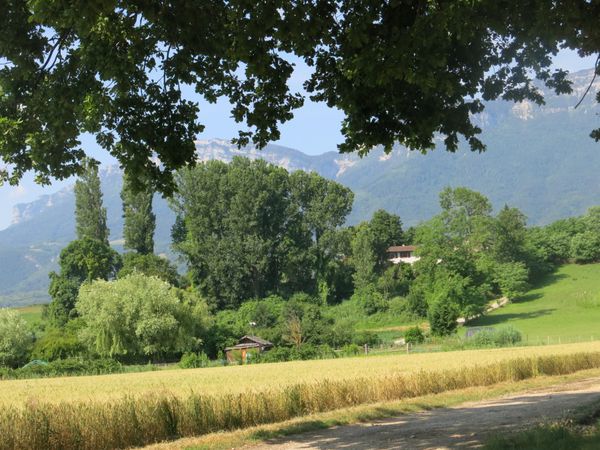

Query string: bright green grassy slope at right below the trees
469 264 600 343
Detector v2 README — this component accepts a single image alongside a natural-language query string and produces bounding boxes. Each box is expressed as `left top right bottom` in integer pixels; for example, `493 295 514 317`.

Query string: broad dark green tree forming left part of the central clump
173 158 300 308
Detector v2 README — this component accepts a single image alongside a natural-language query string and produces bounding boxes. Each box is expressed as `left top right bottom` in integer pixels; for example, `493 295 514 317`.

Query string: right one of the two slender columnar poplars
121 176 156 255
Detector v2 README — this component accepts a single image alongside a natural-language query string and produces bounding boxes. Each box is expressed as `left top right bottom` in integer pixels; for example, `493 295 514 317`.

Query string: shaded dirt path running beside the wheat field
244 378 600 450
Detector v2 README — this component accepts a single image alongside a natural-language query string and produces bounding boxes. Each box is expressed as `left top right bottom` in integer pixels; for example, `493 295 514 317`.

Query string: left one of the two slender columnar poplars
75 159 108 244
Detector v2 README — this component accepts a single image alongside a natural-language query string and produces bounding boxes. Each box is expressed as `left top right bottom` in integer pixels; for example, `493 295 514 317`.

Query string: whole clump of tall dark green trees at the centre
171 158 353 308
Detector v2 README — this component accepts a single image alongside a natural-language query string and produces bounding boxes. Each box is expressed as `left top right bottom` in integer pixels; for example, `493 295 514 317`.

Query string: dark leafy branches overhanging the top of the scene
0 0 600 191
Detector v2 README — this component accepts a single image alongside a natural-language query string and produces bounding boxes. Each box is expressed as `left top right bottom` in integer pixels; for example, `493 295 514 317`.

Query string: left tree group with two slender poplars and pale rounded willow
41 161 210 360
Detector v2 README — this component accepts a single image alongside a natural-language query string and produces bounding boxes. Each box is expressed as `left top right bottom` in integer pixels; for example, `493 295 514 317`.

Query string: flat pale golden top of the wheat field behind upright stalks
0 341 600 406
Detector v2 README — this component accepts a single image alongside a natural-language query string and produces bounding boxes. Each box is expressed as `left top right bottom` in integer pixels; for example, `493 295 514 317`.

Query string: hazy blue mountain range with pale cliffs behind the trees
0 70 600 305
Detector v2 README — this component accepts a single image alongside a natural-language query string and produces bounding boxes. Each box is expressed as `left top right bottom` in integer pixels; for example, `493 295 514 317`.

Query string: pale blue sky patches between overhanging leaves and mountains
0 51 595 230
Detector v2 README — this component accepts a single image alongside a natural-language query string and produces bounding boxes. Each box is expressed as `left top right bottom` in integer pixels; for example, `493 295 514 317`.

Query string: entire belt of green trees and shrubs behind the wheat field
13 158 600 370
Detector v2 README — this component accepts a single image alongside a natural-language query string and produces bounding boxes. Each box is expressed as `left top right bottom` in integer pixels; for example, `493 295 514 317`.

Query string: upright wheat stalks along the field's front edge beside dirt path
0 352 600 449
